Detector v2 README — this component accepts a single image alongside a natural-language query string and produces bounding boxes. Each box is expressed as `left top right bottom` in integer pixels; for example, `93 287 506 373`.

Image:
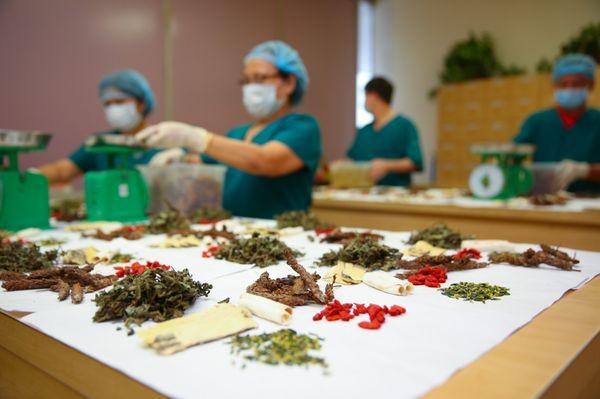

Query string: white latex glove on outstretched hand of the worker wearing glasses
135 122 212 153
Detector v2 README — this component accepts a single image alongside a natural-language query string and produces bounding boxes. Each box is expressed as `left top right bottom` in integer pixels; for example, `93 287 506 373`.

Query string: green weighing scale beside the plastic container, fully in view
85 134 148 222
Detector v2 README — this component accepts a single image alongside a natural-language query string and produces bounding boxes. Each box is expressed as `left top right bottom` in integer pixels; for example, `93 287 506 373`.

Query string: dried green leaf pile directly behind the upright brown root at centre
215 233 303 267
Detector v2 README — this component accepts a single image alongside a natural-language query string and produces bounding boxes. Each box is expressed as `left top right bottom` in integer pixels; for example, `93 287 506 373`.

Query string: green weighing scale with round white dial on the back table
469 143 534 200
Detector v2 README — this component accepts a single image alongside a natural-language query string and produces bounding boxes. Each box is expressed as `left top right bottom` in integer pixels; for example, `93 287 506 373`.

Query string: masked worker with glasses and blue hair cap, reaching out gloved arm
136 41 321 218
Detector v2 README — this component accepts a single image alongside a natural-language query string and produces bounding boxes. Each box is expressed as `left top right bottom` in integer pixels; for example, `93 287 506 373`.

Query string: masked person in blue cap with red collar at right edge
514 54 600 194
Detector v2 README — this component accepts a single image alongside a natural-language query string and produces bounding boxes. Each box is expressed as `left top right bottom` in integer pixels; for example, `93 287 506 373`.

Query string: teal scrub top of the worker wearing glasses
202 114 322 219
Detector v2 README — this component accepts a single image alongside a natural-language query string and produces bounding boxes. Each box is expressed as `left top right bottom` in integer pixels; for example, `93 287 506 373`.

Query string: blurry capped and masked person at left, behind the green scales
38 69 176 184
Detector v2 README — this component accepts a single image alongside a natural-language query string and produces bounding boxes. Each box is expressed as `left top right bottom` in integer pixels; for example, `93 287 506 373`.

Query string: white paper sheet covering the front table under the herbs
0 222 600 399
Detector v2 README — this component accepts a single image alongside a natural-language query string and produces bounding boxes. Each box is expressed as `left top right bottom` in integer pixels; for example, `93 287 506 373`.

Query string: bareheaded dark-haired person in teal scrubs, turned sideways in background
347 77 423 186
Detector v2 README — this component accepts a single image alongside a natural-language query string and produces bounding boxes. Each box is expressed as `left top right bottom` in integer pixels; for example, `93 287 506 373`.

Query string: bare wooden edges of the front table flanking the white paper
0 278 600 398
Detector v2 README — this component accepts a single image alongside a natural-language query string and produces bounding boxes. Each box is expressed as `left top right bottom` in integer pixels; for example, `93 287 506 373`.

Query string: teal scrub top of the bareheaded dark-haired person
347 115 423 186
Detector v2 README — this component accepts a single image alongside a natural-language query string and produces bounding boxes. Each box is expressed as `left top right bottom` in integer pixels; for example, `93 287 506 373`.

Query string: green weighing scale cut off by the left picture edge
0 130 52 231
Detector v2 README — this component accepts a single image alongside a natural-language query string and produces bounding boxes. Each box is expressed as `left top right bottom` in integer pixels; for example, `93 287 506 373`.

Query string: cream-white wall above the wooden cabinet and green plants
375 0 600 182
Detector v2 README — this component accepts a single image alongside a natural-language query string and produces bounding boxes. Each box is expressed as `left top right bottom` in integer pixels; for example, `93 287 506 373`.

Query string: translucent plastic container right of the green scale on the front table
138 164 227 214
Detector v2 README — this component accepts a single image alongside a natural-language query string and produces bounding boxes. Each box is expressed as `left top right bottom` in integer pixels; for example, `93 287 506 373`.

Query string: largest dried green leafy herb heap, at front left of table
94 268 212 332
